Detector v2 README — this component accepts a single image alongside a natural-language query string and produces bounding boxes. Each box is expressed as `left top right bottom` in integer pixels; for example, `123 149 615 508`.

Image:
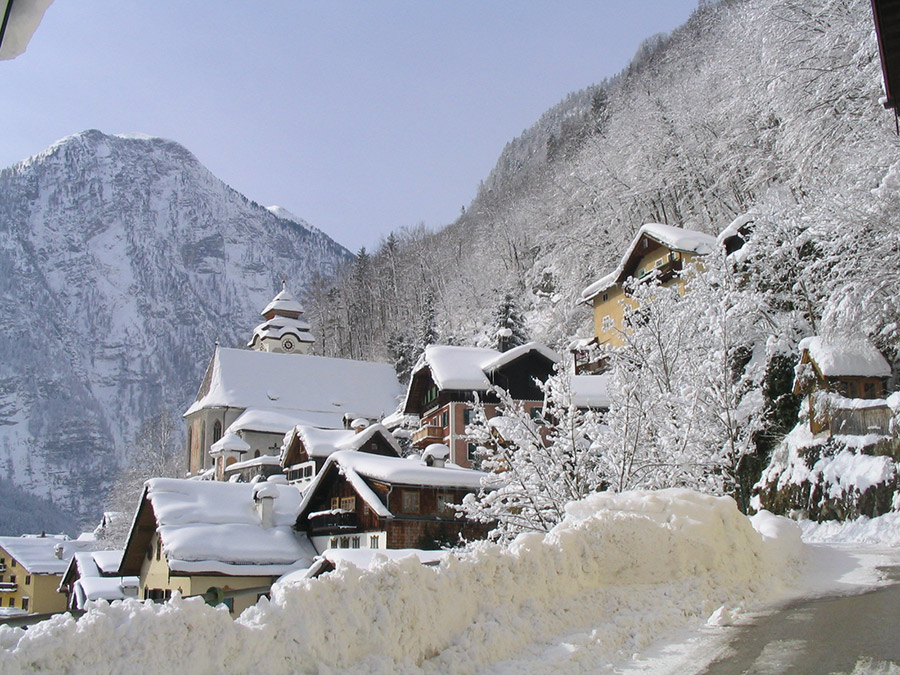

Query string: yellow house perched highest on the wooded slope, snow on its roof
581 223 716 347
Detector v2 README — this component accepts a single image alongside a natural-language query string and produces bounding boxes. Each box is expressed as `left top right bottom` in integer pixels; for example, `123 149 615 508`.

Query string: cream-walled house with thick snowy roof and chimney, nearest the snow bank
116 478 316 614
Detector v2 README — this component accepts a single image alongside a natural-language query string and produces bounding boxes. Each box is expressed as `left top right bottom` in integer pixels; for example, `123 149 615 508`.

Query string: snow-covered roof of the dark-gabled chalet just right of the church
413 342 560 391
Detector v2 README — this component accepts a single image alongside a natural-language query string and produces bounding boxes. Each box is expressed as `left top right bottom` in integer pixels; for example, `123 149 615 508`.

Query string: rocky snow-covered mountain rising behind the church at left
0 130 351 516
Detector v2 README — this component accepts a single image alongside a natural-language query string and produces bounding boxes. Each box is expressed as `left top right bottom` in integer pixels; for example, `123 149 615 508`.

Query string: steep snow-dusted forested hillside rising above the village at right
315 0 900 358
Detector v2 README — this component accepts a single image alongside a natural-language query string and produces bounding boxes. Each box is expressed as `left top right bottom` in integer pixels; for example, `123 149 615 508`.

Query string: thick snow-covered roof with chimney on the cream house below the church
146 478 315 576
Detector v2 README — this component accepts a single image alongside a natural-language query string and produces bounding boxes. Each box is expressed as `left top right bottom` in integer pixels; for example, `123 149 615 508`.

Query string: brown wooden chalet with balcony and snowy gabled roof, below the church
297 450 487 553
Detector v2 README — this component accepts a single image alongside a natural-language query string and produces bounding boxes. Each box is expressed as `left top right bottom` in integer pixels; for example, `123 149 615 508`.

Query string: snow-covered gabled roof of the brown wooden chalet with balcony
300 450 487 518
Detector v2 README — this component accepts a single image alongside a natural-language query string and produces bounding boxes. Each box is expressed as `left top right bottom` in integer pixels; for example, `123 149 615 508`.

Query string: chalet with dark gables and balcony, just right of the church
402 342 560 467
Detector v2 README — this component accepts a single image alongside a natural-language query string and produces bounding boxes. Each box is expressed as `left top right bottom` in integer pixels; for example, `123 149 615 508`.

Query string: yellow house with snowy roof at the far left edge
0 535 92 615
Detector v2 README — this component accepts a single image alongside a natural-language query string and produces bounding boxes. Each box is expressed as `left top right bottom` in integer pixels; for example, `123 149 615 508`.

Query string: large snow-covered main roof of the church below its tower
185 347 403 428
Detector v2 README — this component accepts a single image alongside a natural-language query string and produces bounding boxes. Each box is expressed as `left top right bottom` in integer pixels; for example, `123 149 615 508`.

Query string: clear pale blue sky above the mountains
0 0 697 250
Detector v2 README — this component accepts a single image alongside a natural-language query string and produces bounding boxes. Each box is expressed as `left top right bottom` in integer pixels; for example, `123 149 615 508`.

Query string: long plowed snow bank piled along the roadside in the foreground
0 490 803 673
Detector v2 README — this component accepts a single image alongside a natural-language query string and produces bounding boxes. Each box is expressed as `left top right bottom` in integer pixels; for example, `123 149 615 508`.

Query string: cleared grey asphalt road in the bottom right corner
700 567 900 675
